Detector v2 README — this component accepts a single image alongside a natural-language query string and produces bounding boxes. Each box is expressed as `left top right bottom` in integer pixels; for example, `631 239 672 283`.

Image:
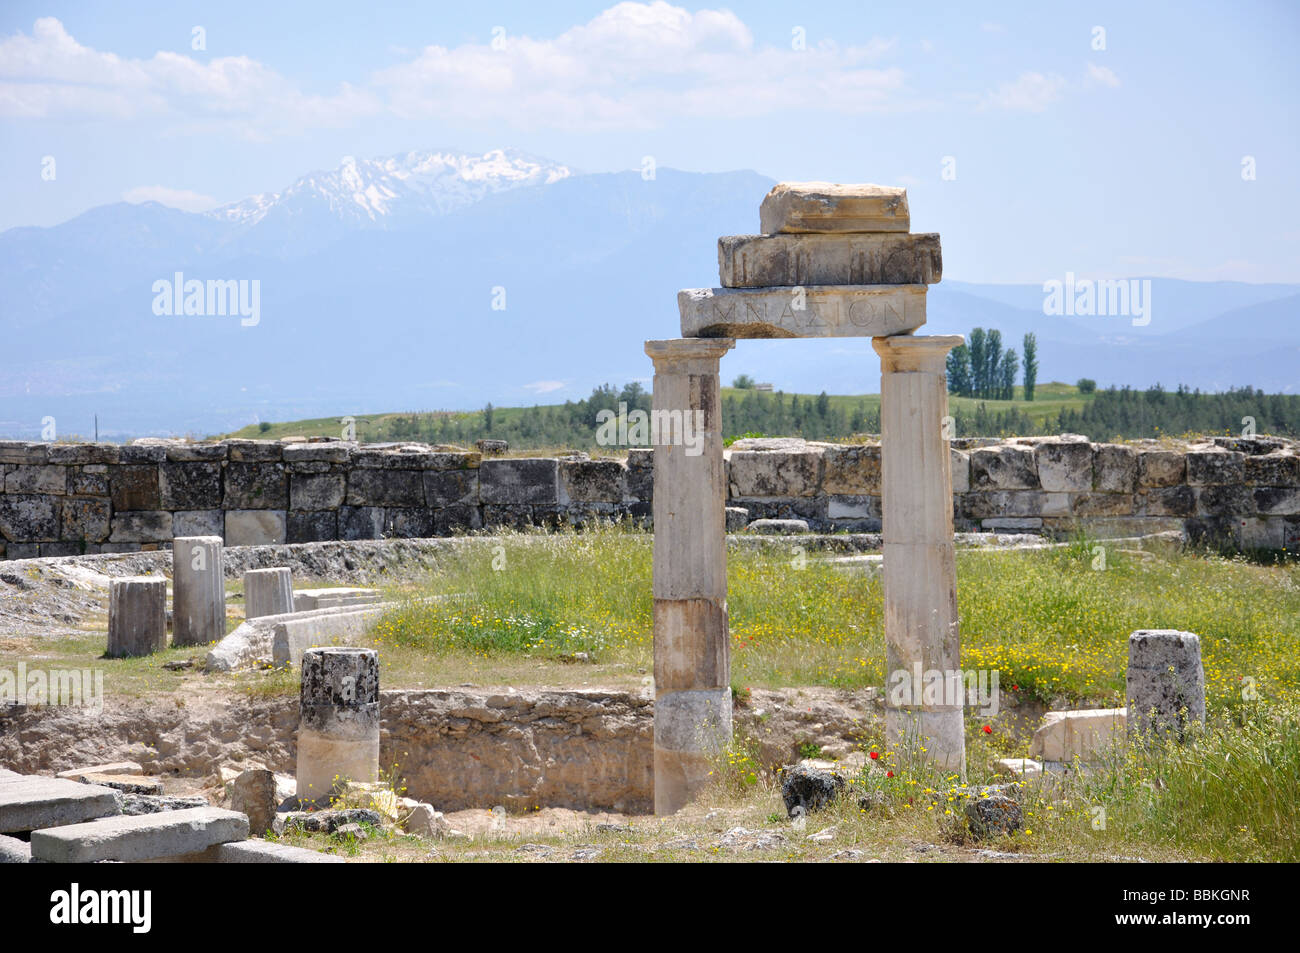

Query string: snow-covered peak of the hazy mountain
208 150 573 229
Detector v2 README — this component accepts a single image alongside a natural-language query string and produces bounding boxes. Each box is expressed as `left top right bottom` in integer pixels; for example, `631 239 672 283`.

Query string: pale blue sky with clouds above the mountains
0 0 1300 282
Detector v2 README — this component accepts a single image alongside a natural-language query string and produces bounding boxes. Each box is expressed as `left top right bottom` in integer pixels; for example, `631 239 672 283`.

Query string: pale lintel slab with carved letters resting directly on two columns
677 285 926 338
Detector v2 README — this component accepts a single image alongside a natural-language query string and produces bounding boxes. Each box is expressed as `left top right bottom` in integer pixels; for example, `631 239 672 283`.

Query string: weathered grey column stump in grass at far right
1125 629 1205 740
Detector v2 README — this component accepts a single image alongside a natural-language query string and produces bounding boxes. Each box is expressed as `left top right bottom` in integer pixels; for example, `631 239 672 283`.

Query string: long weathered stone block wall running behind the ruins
0 437 1300 559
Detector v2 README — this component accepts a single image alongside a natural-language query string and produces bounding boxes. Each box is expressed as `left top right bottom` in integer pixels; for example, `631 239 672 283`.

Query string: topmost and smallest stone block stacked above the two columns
758 182 911 235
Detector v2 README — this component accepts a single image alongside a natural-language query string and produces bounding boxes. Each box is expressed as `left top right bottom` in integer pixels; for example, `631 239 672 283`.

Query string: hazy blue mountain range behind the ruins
0 150 1300 439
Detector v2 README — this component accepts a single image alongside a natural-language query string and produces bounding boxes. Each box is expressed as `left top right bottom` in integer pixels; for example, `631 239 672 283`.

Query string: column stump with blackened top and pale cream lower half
296 647 380 802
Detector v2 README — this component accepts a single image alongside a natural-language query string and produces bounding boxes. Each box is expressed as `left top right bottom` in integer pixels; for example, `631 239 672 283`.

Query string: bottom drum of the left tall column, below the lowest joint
654 688 732 814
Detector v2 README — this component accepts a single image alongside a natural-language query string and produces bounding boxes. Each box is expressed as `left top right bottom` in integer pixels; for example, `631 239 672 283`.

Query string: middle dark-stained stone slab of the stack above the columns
718 231 944 287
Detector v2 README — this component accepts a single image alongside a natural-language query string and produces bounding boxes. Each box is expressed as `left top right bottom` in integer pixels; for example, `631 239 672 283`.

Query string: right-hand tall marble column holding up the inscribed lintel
871 334 966 776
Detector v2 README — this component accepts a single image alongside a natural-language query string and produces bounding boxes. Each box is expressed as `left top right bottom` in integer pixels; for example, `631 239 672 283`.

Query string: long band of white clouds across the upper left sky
0 6 906 131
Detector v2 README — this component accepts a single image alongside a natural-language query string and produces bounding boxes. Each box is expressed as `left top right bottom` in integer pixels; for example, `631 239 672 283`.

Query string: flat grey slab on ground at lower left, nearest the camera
31 807 248 863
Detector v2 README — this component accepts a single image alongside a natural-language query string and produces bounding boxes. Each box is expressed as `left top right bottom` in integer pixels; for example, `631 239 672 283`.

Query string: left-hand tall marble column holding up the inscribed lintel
646 338 736 814
